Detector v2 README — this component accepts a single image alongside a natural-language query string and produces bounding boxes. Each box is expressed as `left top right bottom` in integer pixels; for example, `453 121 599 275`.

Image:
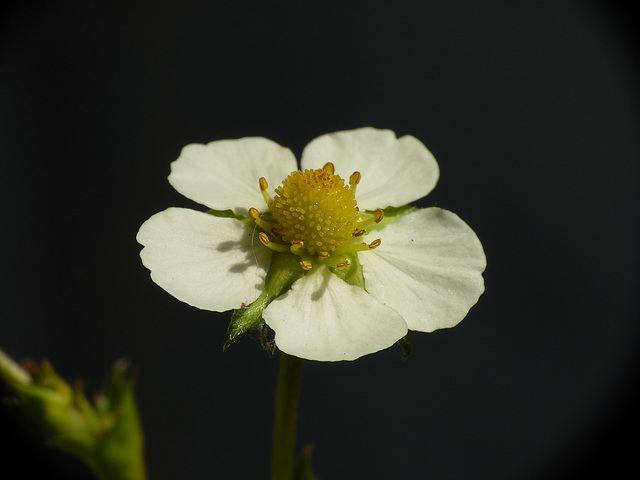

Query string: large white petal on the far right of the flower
358 208 486 332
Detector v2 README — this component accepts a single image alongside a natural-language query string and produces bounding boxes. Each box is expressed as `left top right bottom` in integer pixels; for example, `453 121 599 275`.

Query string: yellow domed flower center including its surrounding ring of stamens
249 163 384 270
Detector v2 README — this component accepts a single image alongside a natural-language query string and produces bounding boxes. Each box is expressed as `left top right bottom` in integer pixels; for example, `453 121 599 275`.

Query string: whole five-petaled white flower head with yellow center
137 128 486 361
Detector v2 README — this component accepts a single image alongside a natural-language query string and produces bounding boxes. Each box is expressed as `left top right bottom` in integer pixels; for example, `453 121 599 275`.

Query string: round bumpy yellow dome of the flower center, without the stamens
271 169 358 255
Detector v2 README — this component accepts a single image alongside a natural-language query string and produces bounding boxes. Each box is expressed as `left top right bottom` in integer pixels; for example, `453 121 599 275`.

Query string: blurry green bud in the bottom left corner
0 350 146 480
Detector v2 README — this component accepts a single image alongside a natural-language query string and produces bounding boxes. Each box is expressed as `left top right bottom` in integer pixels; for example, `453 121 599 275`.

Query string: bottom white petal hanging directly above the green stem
263 266 407 361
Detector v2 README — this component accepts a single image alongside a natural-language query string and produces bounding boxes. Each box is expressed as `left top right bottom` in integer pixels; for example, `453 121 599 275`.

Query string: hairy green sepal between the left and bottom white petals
222 252 307 350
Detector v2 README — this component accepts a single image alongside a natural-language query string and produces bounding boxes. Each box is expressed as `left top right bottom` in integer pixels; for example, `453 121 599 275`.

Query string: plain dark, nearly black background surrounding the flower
0 0 640 480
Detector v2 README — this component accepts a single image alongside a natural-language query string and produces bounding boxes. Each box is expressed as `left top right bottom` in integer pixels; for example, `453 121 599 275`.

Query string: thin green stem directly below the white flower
271 352 302 480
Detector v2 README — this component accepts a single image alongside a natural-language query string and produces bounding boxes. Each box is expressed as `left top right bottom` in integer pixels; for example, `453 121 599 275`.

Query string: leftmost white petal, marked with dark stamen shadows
137 208 271 312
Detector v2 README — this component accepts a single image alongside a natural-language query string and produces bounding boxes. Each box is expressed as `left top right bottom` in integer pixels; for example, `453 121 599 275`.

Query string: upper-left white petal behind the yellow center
169 137 298 215
